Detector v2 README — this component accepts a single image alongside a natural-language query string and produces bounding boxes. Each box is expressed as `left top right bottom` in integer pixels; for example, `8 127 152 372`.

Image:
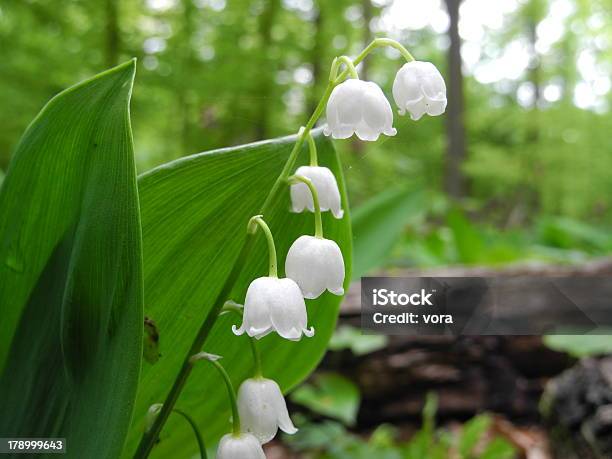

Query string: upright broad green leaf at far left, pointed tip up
0 61 143 458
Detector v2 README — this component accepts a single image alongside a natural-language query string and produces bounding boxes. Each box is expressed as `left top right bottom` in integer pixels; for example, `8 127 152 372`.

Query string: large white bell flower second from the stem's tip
324 79 397 141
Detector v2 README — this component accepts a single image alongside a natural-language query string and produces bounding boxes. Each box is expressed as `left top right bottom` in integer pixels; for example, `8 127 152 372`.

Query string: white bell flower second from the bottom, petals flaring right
238 378 297 444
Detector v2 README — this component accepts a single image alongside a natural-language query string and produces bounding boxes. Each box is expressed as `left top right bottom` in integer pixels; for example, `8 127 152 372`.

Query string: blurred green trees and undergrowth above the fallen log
0 0 612 274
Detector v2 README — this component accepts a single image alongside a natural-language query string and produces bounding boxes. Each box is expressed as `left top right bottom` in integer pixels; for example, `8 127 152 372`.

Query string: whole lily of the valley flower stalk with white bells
136 38 446 459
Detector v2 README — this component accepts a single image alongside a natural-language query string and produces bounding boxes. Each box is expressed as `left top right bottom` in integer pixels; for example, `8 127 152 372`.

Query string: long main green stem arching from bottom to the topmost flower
134 38 404 459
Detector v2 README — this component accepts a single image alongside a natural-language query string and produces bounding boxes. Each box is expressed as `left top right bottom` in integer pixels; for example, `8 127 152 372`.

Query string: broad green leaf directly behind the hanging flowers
125 131 351 458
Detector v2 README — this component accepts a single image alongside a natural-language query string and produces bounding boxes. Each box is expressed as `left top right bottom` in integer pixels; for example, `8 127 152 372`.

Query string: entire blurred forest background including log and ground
0 0 612 459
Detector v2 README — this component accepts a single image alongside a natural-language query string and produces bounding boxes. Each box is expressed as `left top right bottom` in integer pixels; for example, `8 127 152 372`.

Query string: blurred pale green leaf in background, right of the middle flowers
352 186 425 279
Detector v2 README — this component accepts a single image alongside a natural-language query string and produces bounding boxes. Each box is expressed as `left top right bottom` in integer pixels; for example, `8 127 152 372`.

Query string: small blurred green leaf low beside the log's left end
291 373 361 425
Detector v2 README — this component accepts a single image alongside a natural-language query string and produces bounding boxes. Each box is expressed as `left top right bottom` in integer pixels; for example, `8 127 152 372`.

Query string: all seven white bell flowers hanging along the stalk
217 54 446 459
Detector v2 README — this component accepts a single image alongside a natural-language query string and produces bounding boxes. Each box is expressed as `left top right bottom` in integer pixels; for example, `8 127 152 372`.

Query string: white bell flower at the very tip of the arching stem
393 61 446 121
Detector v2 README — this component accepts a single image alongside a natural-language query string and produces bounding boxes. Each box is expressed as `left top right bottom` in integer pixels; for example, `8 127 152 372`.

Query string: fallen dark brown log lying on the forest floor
322 258 612 428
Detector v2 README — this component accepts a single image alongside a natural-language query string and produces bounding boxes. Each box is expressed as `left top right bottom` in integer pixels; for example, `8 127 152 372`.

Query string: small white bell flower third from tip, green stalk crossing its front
290 166 344 218
